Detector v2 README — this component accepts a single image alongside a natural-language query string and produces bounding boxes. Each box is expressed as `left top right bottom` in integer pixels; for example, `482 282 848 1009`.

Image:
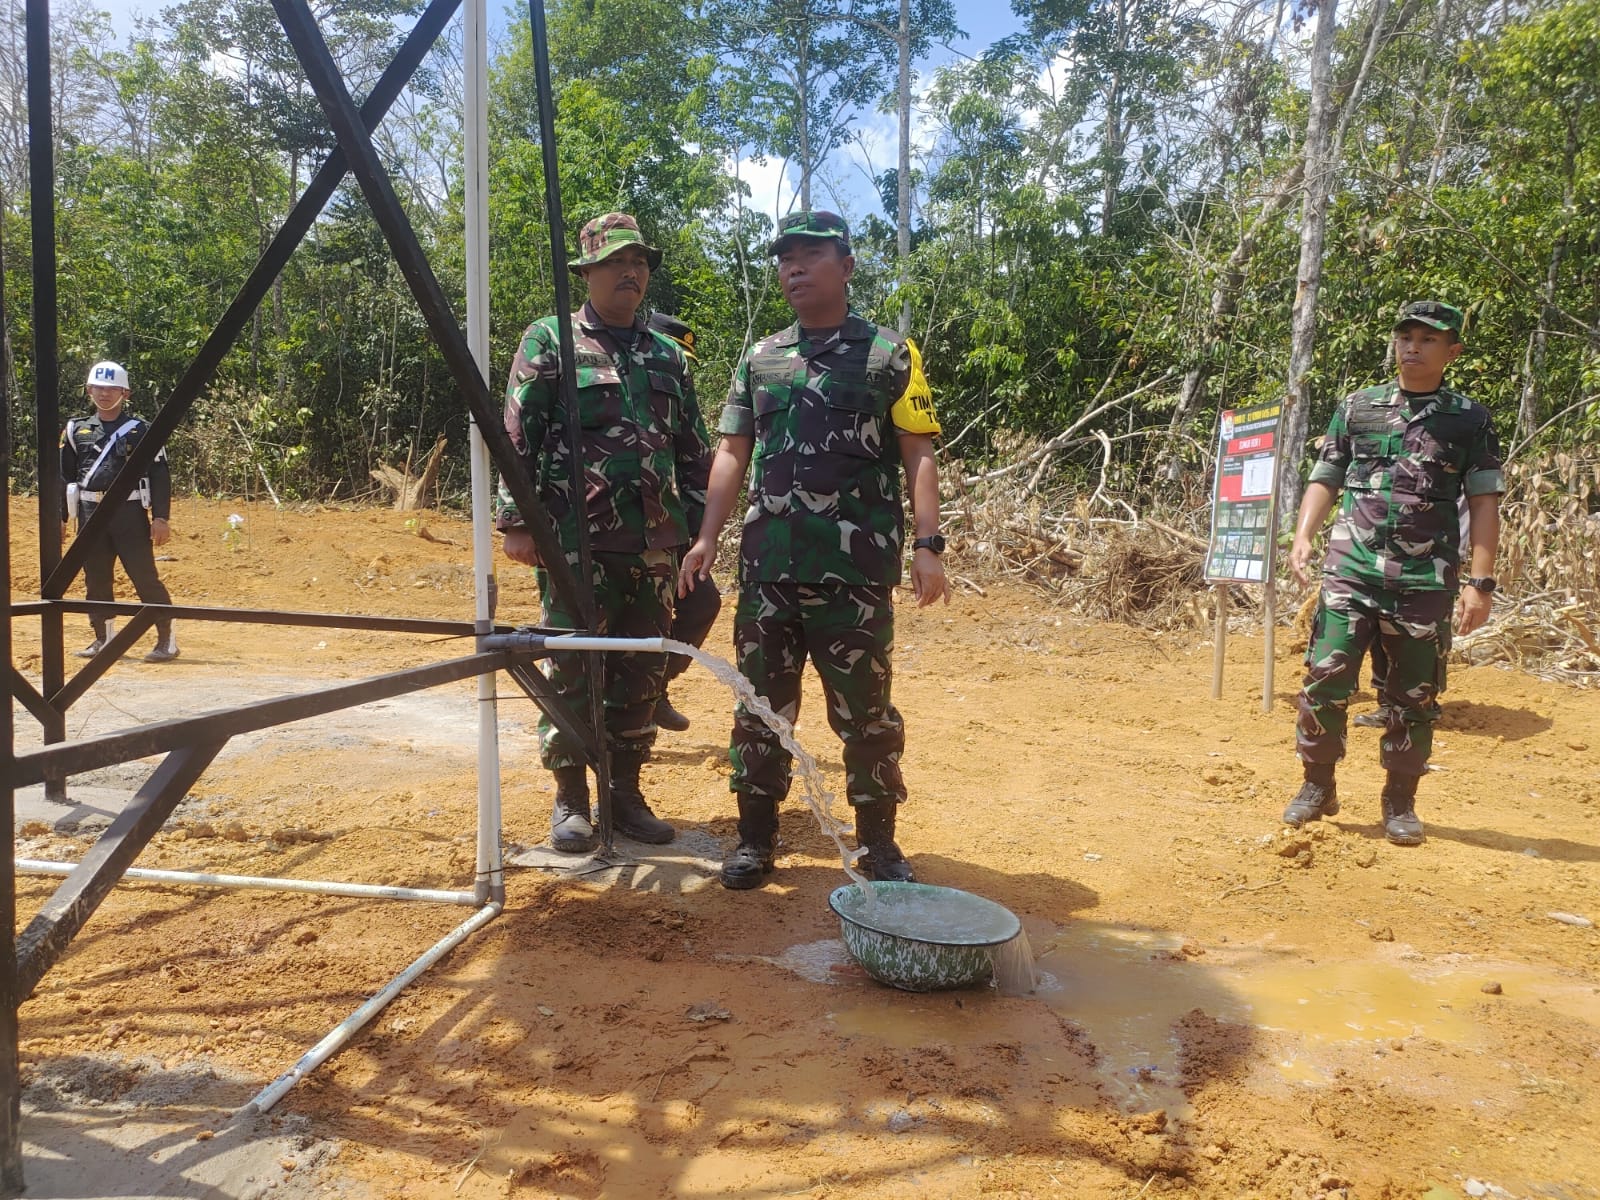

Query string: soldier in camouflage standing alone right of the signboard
1283 301 1506 846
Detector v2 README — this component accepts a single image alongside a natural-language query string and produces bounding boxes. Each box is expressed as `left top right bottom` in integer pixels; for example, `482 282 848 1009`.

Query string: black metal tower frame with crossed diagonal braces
0 0 611 1197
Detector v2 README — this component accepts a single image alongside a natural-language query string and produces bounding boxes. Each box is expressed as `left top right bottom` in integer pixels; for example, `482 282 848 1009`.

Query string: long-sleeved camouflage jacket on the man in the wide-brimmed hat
494 304 710 552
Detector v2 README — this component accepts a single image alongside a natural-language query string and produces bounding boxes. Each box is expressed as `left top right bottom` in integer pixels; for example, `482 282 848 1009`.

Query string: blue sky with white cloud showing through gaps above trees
87 0 1021 219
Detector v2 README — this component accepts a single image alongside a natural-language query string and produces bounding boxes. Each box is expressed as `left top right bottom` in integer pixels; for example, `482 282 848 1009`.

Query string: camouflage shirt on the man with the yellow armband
720 314 910 584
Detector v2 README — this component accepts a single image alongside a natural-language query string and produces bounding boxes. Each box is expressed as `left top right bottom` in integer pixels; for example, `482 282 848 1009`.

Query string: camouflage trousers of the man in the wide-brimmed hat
534 550 678 771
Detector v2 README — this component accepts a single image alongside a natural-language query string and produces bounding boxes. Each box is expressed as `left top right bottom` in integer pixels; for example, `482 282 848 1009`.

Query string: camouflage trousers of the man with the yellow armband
728 582 906 805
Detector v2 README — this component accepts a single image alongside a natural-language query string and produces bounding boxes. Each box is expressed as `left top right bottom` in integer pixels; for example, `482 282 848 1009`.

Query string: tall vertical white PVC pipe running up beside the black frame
461 0 506 902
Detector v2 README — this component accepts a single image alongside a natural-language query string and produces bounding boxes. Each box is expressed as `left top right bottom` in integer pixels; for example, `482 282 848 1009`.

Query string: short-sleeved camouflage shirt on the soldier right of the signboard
1310 382 1506 592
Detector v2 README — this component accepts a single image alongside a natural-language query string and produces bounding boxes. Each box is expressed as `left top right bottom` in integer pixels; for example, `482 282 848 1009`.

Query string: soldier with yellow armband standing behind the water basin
678 211 949 890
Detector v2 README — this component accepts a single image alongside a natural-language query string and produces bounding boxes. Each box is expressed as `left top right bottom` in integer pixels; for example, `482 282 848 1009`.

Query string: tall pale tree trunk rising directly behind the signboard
1278 0 1338 528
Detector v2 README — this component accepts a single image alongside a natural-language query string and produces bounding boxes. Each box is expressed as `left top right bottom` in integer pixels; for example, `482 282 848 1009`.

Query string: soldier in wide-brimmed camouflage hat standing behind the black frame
496 213 710 853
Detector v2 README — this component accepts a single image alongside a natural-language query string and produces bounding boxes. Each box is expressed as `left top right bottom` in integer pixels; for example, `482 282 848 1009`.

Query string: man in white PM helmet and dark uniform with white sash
61 362 178 662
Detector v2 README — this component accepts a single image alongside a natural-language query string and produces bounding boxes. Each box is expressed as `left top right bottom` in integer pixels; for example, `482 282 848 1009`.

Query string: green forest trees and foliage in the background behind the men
0 0 1600 508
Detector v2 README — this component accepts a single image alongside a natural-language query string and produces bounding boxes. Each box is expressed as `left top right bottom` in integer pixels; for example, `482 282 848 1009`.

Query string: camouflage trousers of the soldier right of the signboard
1294 576 1456 774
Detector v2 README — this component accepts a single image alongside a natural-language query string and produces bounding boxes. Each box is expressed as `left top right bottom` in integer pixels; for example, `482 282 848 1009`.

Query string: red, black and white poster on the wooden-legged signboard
1205 400 1283 584
